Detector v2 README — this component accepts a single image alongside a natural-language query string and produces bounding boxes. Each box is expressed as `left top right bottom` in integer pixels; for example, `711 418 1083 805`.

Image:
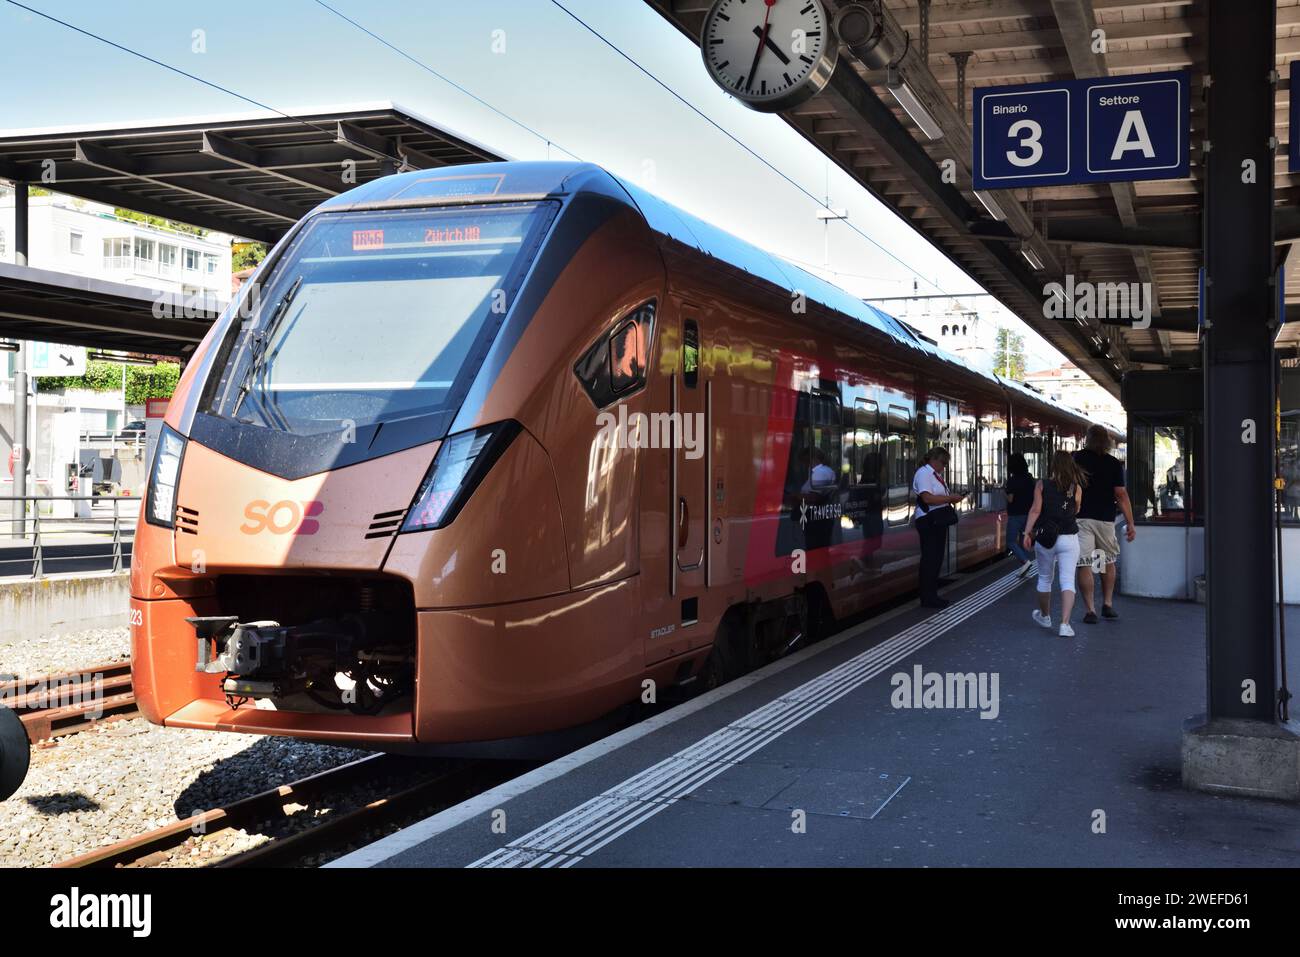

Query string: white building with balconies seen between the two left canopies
0 180 231 302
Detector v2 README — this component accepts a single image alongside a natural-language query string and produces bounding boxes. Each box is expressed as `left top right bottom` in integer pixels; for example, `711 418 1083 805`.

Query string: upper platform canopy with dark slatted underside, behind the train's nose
0 103 503 242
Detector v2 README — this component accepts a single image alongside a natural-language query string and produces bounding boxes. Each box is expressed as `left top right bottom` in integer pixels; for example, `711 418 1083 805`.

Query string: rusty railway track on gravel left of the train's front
0 661 139 744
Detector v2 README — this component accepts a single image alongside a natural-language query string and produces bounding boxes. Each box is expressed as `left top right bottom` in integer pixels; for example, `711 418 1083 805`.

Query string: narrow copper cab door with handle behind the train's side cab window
670 308 712 613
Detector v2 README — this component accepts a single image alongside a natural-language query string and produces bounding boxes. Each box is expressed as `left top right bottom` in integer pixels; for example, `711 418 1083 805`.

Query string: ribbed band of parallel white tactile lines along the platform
469 572 1023 867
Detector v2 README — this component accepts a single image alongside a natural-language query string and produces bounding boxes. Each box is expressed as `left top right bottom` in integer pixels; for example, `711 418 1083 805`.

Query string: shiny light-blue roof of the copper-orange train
316 161 1110 428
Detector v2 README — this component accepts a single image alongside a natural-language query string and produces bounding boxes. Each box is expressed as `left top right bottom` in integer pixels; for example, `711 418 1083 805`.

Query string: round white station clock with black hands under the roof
699 0 839 112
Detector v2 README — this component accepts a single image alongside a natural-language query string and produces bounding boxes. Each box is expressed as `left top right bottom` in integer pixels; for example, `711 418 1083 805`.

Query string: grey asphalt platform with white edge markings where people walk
333 563 1300 867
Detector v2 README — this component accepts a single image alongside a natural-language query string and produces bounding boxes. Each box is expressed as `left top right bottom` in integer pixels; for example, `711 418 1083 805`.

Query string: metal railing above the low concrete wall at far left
0 495 140 579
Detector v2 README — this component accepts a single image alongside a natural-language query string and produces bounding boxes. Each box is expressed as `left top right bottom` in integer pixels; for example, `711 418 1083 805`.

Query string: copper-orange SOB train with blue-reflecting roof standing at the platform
130 163 1107 753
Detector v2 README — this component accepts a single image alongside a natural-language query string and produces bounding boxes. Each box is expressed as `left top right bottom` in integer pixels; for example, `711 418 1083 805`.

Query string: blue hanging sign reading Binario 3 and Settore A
971 70 1190 190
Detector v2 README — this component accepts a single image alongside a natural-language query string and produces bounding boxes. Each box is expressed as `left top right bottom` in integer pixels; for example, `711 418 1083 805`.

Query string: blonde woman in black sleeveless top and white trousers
1024 450 1088 638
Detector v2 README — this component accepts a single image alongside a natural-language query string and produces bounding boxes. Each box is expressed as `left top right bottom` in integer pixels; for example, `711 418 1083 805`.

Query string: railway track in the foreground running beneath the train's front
55 754 520 869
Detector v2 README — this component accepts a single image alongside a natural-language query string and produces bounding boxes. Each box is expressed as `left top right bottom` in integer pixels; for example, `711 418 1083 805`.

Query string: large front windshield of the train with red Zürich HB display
203 203 554 434
